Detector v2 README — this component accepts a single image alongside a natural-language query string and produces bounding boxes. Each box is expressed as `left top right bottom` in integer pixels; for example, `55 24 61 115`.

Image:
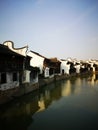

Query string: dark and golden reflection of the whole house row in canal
0 75 98 130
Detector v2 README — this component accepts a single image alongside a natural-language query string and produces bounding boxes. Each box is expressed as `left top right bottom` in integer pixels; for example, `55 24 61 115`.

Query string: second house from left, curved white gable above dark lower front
3 41 38 87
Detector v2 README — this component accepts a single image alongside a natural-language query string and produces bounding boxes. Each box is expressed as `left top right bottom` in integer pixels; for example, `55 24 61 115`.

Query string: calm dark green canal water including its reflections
0 75 98 130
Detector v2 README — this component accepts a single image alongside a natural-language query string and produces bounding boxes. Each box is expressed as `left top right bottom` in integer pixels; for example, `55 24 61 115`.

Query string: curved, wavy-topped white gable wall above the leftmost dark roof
4 41 28 56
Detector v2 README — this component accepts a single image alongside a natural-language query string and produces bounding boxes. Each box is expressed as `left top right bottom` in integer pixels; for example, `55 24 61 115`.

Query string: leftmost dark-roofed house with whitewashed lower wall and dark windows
0 44 25 91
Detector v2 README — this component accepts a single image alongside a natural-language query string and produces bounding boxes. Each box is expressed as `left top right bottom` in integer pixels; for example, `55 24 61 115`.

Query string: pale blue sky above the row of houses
0 0 98 59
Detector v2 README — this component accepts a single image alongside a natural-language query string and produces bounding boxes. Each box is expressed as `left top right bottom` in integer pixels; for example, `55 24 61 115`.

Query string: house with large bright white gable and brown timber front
27 51 61 78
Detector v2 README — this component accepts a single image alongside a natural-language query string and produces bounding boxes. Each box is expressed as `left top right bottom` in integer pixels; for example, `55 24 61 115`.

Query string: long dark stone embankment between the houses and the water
0 72 93 105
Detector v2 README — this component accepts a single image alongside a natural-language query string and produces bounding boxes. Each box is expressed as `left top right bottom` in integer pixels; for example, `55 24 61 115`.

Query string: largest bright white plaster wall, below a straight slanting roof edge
27 52 44 74
